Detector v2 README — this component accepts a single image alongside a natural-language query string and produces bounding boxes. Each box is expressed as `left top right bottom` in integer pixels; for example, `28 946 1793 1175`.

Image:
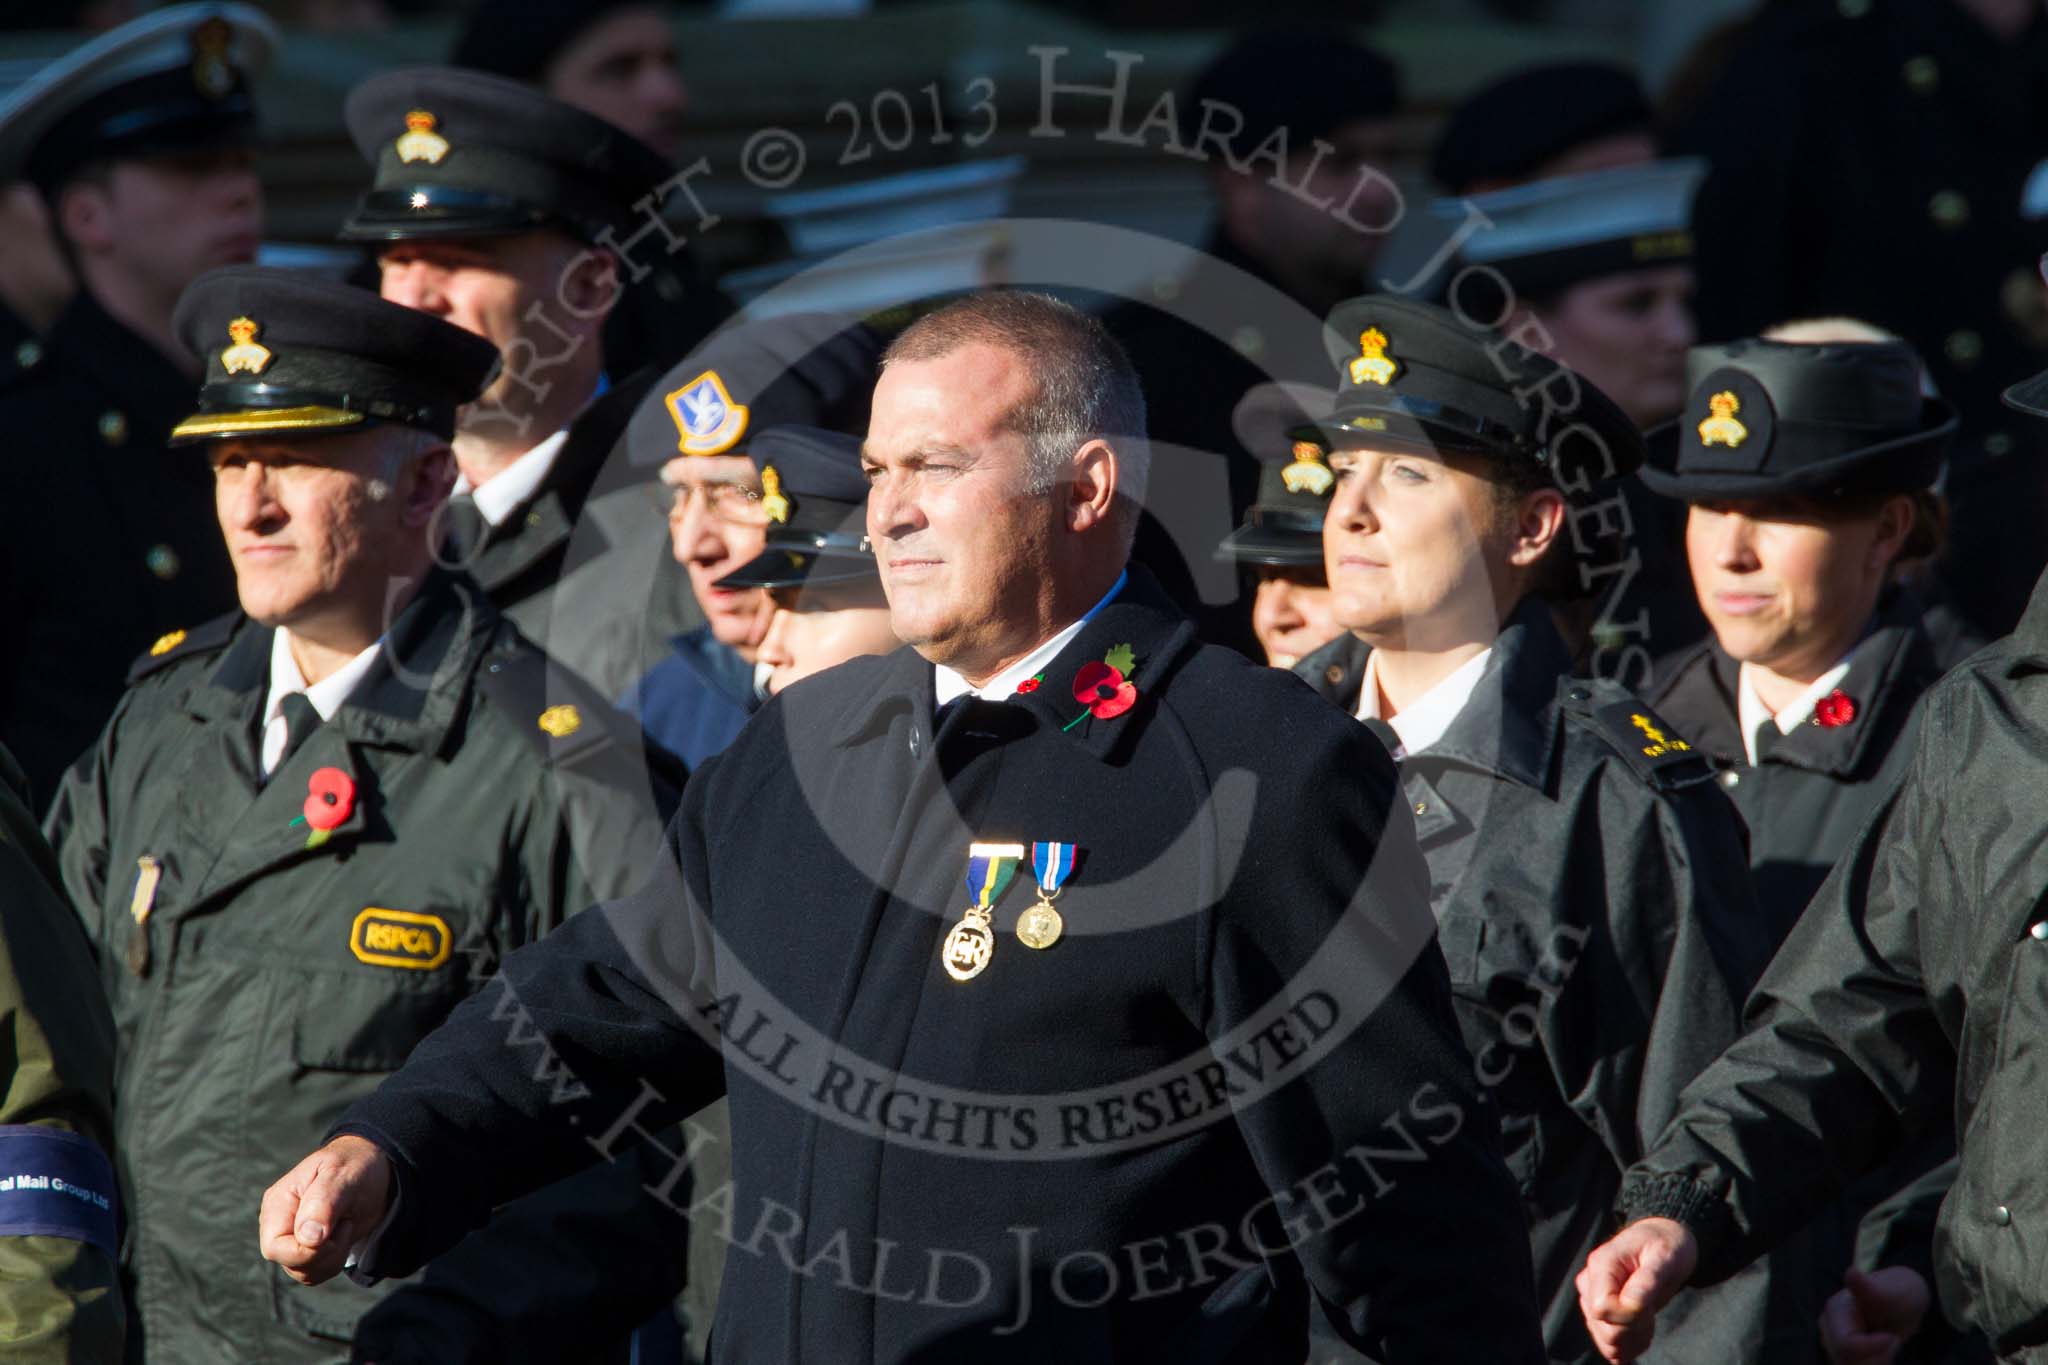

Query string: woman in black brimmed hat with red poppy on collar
1642 340 1956 935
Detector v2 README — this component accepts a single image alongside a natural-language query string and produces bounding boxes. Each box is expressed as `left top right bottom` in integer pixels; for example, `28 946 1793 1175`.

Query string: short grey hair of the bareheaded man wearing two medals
883 289 1151 551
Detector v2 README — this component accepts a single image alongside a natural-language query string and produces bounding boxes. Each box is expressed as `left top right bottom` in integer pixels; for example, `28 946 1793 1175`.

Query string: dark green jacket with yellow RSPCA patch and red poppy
49 571 680 1365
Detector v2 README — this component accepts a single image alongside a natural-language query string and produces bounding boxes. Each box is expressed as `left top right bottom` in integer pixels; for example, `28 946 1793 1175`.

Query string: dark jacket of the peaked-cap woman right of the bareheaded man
1296 600 1785 1365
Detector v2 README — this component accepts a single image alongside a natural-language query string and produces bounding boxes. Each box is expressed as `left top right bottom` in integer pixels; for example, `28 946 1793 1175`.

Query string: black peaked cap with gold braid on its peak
170 266 498 444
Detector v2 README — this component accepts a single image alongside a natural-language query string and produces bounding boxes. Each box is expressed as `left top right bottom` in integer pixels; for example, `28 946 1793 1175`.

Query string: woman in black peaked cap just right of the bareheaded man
1296 297 1812 1361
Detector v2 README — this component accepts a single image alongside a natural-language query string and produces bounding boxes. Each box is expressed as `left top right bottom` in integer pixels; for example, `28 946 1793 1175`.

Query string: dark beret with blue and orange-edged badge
627 313 883 467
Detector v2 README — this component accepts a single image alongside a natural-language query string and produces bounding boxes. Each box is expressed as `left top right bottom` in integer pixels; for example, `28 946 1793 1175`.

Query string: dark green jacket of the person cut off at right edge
1622 568 2048 1361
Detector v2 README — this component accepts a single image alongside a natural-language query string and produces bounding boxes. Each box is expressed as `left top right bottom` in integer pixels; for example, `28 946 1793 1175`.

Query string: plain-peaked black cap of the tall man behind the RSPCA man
342 65 674 241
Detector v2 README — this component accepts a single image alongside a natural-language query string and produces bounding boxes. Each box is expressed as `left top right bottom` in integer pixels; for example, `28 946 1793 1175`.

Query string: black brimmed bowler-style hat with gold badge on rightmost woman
1642 340 1956 501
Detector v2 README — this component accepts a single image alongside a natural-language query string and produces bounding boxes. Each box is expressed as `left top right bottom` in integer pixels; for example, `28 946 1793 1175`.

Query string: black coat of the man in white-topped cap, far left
0 291 236 810
